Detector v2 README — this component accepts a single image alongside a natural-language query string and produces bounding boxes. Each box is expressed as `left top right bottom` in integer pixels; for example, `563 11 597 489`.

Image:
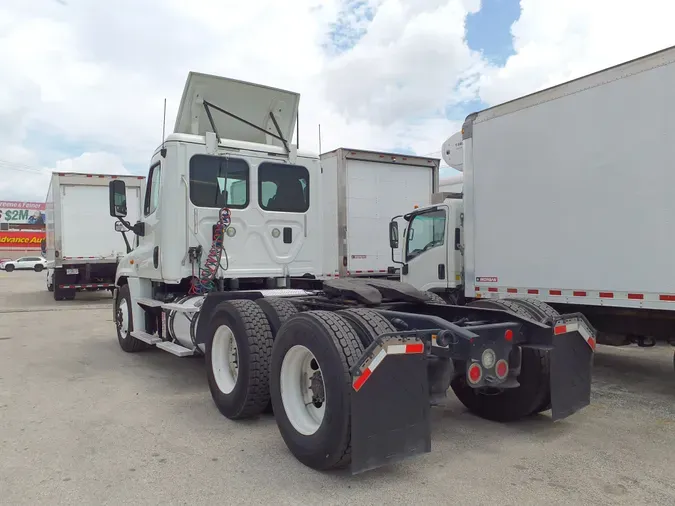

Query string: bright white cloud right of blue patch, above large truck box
479 0 675 104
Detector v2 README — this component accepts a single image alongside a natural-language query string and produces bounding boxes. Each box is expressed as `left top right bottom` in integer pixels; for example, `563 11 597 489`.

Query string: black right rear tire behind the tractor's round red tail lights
450 300 550 422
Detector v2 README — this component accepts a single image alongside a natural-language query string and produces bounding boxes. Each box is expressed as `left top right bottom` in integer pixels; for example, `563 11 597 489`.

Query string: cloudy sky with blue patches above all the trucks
0 0 675 201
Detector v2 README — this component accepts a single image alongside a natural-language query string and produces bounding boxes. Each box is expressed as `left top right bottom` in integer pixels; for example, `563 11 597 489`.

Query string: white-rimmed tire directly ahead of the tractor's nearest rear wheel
206 300 274 420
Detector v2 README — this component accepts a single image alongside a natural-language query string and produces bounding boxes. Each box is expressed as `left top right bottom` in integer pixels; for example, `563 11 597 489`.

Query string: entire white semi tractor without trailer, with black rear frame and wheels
109 73 594 473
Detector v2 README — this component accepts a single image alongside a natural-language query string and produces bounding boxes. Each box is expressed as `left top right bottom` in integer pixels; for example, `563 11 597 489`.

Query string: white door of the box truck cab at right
401 205 454 290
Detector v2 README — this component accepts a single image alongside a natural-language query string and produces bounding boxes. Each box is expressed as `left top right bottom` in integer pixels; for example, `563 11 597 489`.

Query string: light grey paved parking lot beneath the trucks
0 272 675 506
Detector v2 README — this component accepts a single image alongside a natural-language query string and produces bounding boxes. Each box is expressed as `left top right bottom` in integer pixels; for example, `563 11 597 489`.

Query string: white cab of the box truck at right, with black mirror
390 192 464 302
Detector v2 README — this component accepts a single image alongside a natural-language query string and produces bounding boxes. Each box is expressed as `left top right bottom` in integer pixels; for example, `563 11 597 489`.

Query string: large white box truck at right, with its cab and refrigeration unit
402 43 675 368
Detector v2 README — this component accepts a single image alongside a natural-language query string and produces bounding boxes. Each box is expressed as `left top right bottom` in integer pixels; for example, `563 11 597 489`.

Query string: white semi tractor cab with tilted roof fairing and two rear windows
110 72 322 332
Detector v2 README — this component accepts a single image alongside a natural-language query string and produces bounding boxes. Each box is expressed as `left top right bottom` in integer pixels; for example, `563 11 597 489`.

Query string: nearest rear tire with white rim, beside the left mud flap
271 311 363 471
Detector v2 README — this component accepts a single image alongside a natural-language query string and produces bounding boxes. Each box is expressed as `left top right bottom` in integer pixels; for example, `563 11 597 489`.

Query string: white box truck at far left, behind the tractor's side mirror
45 172 145 300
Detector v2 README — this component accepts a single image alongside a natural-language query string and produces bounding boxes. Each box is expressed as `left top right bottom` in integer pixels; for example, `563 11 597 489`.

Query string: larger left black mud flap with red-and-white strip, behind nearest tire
351 338 431 474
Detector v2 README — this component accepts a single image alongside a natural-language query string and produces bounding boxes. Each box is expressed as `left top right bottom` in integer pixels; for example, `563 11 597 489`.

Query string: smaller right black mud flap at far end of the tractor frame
549 315 596 420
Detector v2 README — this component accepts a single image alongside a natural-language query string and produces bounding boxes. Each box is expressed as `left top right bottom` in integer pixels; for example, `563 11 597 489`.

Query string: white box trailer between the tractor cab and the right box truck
321 148 440 278
